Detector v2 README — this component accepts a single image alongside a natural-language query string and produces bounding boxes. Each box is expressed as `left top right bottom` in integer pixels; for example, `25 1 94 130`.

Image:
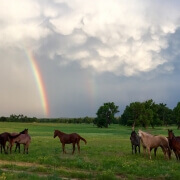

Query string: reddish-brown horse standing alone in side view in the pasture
54 130 87 154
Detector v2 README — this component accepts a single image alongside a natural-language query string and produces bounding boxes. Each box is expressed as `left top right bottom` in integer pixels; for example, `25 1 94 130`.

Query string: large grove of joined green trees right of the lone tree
120 99 177 128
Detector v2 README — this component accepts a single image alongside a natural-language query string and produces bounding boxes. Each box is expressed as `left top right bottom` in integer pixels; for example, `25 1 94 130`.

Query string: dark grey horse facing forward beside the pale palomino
130 131 140 154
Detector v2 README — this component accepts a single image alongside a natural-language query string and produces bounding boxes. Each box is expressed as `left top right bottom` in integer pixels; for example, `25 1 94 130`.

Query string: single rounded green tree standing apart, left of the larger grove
94 102 119 128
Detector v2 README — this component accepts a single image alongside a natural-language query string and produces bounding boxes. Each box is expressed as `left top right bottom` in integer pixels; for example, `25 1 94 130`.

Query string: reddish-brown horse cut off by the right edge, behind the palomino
168 129 180 160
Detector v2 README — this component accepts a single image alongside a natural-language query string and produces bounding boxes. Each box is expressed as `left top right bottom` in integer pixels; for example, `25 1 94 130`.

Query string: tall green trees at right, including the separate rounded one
94 99 180 129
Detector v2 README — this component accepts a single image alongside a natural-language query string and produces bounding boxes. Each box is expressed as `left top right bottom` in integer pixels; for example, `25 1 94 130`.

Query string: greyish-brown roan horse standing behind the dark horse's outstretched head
9 129 31 154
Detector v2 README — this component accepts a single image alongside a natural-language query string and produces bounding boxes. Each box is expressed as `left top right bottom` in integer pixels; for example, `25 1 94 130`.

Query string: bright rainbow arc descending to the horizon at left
25 49 49 117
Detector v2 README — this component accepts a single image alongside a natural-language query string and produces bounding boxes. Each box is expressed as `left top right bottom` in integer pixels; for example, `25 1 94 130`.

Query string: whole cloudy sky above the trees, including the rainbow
0 0 180 118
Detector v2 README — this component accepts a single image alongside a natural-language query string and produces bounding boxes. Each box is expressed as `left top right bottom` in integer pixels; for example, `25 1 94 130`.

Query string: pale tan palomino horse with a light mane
138 130 171 159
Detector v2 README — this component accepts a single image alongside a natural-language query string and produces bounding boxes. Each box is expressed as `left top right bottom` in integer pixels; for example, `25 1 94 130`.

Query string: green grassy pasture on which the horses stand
0 122 180 180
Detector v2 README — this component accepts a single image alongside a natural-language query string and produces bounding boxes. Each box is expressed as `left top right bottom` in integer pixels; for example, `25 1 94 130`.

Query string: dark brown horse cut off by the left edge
0 132 21 154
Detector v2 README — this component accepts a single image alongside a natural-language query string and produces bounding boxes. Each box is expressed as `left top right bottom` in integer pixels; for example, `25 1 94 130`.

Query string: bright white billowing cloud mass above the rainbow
0 0 180 76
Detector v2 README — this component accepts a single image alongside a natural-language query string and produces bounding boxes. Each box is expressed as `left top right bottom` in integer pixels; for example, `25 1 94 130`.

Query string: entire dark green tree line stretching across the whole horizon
0 99 180 129
